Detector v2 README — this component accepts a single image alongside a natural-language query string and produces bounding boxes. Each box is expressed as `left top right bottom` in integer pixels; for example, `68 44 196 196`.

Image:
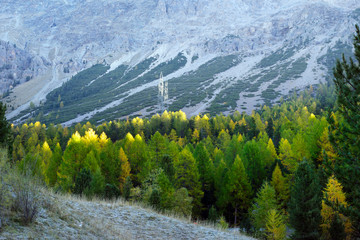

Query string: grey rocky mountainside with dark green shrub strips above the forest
0 0 360 124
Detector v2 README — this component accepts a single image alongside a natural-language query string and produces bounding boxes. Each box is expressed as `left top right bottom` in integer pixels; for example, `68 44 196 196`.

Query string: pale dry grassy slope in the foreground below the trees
0 191 253 240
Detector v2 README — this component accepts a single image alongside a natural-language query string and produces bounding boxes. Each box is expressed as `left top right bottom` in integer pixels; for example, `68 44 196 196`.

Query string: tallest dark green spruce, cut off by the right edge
327 25 360 238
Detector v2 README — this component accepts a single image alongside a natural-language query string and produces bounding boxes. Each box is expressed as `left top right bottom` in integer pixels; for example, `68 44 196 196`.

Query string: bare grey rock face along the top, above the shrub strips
0 0 360 69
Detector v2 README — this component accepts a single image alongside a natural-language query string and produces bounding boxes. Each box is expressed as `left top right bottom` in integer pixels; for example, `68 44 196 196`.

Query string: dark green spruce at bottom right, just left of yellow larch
289 161 322 240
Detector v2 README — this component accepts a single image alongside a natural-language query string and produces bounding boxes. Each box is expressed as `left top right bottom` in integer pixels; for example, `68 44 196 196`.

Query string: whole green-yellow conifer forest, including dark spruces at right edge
1 28 360 239
